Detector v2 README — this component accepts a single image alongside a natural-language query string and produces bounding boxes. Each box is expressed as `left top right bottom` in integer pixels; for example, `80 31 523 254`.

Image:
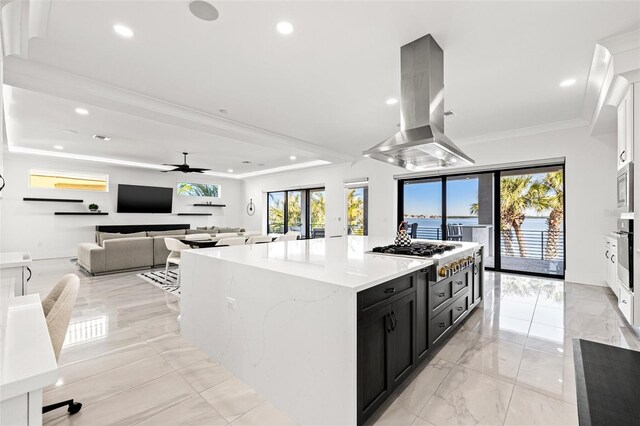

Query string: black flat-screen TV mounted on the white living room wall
118 185 173 213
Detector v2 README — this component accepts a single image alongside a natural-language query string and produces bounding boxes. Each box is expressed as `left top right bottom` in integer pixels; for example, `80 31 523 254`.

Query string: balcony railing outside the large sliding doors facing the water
416 226 564 260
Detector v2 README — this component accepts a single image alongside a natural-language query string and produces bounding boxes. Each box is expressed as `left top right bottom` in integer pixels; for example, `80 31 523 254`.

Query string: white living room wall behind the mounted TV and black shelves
0 153 244 259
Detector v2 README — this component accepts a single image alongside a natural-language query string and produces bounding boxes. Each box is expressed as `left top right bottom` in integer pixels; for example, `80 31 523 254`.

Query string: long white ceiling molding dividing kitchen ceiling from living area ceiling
4 56 353 162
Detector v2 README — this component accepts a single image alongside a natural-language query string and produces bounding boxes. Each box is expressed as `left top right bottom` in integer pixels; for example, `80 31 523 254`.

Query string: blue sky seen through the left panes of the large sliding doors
404 178 478 216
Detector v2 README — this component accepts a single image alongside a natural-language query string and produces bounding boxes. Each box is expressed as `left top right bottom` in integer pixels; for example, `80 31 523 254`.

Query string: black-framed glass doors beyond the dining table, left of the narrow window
267 188 325 238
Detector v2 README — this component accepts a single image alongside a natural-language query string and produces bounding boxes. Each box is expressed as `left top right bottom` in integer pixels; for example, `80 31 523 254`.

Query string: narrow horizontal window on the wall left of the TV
29 170 109 192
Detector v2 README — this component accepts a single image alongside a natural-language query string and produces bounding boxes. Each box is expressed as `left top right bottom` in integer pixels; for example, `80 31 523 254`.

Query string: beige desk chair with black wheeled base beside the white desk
42 274 82 414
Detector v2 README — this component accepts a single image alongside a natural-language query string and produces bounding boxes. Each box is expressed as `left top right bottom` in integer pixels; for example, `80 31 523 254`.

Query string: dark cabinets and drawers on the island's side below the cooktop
357 258 482 424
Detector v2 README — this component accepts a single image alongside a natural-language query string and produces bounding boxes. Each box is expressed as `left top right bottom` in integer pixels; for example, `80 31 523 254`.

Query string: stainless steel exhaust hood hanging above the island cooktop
363 34 475 171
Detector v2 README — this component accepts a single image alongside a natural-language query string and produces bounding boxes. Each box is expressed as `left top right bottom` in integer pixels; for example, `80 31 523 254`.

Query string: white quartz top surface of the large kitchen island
183 236 478 291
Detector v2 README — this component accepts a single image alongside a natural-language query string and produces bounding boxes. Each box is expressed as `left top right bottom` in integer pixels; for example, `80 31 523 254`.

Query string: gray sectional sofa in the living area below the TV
78 227 245 274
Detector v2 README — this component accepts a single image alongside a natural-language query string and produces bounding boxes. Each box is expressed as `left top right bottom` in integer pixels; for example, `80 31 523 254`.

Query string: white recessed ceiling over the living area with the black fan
4 88 313 174
